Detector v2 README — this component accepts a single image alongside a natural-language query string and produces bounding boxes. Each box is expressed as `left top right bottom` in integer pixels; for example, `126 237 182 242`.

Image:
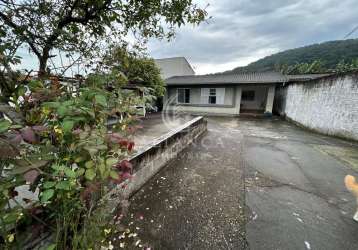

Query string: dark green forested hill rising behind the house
224 39 358 73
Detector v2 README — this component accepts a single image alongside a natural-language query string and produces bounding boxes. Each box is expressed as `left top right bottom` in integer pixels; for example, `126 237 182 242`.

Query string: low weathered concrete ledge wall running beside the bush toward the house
107 117 207 200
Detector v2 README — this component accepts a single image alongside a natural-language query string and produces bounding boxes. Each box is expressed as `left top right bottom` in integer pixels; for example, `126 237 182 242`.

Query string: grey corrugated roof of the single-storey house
165 72 288 86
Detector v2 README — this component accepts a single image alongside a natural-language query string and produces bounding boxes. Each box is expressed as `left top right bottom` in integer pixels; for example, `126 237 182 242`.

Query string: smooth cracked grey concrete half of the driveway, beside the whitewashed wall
243 119 358 249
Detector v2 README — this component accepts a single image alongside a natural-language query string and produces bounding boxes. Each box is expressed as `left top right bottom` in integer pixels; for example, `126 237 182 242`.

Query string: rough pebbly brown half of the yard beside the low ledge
121 116 246 249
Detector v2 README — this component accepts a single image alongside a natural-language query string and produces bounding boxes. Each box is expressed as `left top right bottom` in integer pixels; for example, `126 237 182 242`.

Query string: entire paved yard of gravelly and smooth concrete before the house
121 118 358 249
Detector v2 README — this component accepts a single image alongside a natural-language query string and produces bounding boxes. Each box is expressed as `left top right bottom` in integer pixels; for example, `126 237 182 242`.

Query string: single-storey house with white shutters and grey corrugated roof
164 72 288 116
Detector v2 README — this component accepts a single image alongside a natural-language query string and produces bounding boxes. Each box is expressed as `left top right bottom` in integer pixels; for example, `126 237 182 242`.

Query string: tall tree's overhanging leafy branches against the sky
0 0 206 75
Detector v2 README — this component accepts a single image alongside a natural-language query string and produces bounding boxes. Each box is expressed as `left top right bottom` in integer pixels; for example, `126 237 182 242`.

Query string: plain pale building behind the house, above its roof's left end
155 57 195 79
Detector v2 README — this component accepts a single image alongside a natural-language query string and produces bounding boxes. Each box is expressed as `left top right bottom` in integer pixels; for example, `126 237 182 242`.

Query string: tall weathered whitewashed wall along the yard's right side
274 73 358 140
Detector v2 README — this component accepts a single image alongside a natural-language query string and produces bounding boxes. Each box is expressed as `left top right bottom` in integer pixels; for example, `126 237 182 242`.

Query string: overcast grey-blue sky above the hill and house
148 0 358 74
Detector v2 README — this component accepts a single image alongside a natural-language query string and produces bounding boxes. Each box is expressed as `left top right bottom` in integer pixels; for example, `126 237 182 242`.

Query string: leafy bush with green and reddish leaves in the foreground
0 72 143 249
